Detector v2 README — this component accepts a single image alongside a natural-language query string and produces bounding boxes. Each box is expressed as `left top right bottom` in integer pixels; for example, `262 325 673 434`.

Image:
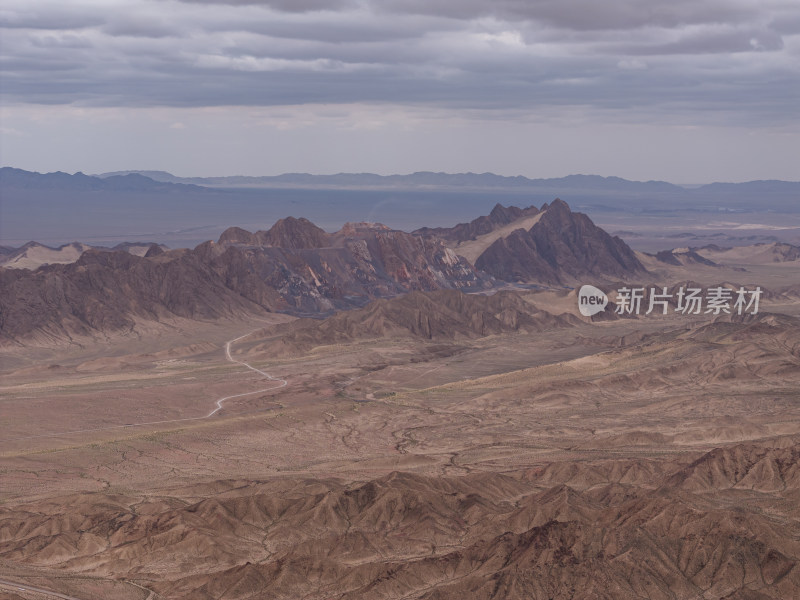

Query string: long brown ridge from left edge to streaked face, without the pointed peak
0 218 488 340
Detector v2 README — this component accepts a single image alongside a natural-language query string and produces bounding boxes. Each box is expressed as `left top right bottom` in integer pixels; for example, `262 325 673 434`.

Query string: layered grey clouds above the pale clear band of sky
0 0 800 126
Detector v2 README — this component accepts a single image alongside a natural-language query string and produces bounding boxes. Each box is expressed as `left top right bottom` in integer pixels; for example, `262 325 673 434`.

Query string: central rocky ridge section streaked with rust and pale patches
208 218 488 313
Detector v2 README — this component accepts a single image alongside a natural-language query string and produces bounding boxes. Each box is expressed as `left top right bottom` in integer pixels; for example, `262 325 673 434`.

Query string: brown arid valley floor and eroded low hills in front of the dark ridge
0 246 800 600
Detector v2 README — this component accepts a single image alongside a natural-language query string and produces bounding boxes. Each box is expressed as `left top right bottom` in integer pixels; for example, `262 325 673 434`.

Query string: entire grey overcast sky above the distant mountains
0 0 800 183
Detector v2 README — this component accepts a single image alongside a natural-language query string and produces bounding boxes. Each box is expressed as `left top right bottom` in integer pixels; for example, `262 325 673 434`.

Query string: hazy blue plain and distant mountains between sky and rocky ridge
0 167 800 253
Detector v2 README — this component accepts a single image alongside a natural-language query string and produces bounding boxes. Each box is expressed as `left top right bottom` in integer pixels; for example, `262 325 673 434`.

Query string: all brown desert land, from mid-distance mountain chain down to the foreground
0 201 800 600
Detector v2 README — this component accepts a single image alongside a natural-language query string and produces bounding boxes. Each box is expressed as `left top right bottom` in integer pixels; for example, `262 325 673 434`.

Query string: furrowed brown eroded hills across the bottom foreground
0 443 800 600
